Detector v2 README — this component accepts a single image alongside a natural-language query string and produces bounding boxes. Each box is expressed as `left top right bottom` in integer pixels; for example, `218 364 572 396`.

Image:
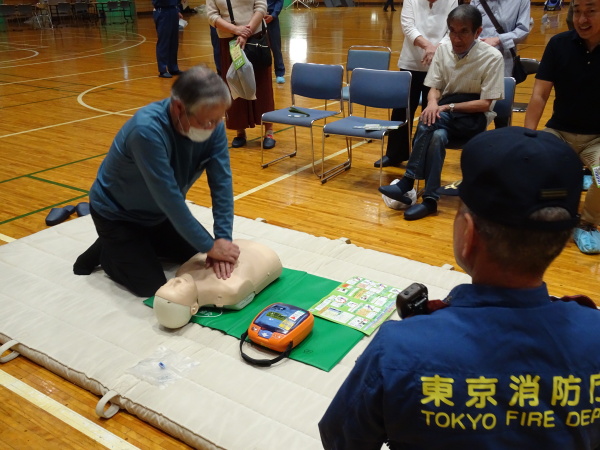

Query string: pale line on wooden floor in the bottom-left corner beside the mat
0 370 138 450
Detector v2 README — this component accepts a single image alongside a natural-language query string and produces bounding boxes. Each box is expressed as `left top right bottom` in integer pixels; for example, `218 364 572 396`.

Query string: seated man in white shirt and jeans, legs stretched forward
379 5 504 220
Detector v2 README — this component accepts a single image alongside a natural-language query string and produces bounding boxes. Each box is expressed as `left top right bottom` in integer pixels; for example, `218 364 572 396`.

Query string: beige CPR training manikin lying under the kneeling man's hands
154 239 283 328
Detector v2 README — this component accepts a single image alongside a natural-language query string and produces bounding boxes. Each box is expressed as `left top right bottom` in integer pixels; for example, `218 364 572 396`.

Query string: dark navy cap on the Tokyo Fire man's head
458 127 583 230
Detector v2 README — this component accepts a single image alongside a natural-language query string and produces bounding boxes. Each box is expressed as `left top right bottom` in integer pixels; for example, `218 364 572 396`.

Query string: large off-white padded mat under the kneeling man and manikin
0 205 470 450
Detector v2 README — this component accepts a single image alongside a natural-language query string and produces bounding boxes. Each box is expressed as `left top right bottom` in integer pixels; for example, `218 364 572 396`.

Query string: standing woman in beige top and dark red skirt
206 0 275 149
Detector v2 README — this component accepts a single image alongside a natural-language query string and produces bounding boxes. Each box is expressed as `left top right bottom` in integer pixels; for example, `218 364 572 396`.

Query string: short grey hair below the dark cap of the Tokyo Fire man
461 203 573 275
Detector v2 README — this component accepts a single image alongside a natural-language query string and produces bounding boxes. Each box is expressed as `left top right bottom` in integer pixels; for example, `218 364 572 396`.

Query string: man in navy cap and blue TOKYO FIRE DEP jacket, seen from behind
319 127 600 450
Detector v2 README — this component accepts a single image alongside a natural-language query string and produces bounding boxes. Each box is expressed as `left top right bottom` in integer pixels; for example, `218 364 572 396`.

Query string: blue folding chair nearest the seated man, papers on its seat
321 68 412 185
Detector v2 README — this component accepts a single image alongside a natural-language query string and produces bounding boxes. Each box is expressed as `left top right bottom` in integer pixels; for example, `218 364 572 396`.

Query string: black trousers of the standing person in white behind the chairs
386 70 429 164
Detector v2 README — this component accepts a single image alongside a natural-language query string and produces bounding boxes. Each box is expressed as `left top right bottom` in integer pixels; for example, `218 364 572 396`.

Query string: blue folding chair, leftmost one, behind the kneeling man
261 63 344 178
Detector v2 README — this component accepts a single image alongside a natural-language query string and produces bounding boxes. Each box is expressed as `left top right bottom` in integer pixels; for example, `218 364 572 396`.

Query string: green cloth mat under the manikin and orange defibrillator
144 269 364 372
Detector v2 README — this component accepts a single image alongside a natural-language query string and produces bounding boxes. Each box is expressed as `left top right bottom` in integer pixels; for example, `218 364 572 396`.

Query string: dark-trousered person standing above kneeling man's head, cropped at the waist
152 0 183 78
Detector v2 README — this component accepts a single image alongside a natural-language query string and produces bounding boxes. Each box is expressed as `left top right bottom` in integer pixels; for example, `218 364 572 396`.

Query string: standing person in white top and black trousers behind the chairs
375 0 458 167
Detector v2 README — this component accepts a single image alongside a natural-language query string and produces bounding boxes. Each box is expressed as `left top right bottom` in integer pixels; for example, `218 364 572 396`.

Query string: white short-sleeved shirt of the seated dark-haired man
425 41 504 123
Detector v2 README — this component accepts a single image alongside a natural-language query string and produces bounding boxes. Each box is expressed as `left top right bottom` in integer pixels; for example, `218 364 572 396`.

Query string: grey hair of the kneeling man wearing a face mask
171 64 231 113
